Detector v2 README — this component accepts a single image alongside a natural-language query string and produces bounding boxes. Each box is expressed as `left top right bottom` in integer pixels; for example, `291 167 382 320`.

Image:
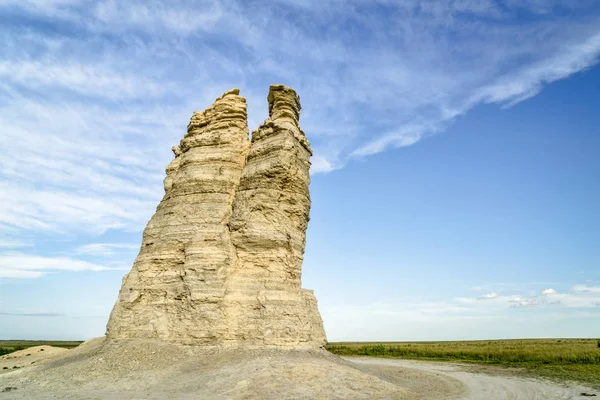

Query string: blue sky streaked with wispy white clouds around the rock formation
0 0 600 340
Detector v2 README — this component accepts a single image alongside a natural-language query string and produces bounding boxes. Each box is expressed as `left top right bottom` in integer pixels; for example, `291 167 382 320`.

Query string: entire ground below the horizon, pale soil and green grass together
0 338 600 400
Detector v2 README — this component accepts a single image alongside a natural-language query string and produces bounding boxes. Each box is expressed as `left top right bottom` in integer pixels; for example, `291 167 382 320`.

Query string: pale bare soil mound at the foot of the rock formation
0 338 454 399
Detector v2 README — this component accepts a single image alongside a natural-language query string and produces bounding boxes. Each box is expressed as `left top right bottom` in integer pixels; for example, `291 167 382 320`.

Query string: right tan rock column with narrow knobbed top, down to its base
226 85 325 347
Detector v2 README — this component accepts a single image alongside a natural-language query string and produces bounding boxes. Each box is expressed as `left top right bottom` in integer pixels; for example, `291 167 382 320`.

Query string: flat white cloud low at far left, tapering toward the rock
0 253 121 278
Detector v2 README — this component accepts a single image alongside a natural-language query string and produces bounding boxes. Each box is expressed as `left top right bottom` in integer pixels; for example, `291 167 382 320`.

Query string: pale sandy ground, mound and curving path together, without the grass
0 338 594 400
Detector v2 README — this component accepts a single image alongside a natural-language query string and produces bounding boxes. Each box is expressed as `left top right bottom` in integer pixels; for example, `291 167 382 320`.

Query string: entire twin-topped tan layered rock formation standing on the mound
107 85 325 347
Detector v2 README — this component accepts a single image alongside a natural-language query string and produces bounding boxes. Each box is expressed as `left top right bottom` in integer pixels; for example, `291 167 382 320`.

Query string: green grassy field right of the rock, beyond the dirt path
326 339 600 388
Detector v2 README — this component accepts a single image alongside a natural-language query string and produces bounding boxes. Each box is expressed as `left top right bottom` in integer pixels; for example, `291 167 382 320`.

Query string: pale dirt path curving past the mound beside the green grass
345 357 600 400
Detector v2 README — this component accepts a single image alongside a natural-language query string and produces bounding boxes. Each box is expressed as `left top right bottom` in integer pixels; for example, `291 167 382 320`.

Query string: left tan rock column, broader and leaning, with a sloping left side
107 89 249 343
